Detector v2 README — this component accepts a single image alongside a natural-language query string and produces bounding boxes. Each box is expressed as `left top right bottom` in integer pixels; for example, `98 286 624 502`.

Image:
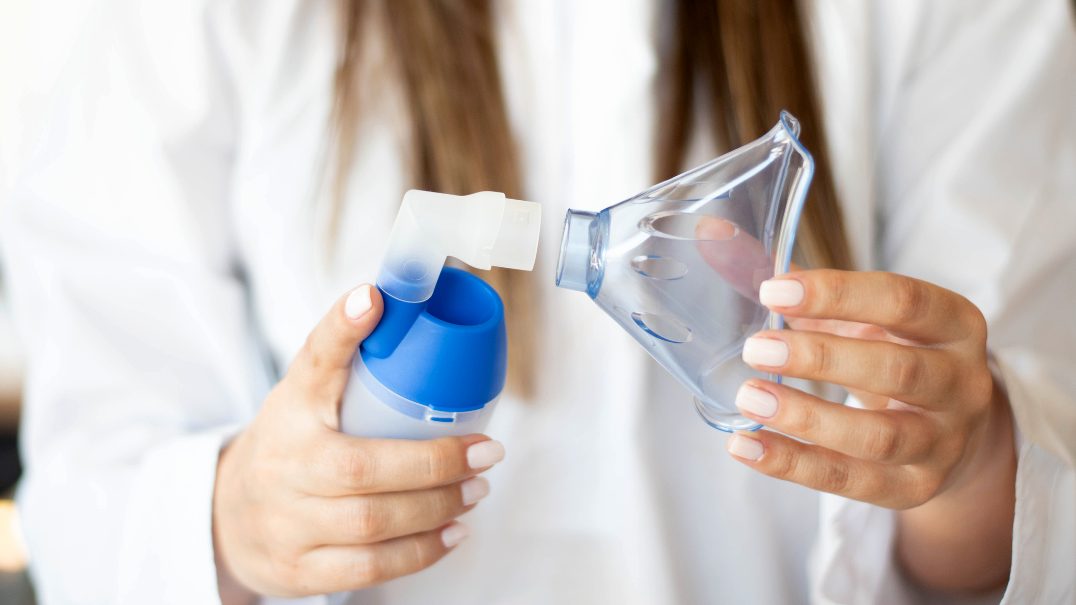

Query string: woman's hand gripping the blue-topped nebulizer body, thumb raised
213 285 505 605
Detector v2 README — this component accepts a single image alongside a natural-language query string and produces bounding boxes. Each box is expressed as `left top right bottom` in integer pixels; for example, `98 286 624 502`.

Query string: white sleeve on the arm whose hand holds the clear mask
810 0 1076 605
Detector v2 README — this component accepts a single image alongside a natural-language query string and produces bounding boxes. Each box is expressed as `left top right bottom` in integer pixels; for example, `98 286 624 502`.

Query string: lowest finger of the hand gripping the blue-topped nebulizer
296 522 469 594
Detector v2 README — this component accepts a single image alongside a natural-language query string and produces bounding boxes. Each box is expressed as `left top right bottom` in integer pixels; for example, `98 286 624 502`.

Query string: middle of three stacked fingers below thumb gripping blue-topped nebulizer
305 477 490 546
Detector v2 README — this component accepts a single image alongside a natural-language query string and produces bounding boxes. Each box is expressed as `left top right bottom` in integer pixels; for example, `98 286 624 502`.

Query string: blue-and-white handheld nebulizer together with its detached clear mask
341 112 813 438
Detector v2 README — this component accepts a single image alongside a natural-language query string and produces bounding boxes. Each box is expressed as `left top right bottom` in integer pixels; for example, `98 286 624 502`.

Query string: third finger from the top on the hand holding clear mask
736 379 937 464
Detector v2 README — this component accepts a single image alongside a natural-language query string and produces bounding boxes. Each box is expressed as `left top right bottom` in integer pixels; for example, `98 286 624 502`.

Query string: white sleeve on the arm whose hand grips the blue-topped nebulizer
3 0 268 605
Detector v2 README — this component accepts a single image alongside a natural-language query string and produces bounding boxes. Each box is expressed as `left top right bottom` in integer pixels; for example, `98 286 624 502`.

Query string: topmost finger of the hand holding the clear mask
760 269 986 343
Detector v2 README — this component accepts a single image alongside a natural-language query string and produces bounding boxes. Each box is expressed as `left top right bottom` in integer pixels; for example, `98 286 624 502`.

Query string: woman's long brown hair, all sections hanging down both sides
334 0 851 396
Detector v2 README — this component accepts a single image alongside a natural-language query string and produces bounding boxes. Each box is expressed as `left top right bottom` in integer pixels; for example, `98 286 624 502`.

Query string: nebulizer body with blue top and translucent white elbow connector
340 191 541 439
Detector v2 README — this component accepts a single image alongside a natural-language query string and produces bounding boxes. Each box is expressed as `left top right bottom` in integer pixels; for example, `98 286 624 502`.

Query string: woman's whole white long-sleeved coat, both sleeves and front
3 0 1076 605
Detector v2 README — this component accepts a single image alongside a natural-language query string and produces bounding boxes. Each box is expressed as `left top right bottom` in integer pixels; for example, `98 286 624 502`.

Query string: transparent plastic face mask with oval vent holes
556 112 815 432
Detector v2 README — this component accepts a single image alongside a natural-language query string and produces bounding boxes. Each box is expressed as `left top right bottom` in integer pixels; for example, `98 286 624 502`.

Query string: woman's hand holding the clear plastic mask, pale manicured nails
728 270 1016 591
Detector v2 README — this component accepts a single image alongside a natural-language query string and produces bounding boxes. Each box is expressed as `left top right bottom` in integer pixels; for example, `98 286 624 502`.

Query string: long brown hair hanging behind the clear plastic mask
656 0 852 269
